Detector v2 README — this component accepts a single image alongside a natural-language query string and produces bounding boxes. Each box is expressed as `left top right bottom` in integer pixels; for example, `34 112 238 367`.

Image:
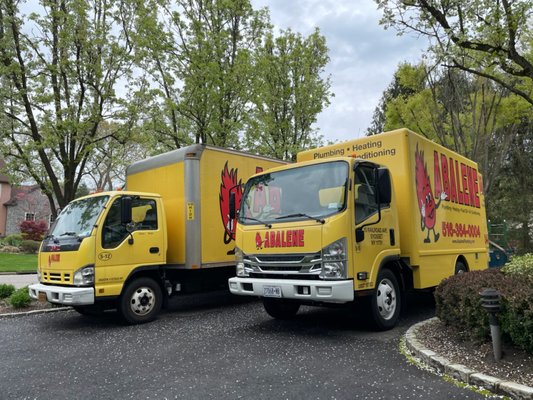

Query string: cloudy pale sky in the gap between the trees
251 0 428 141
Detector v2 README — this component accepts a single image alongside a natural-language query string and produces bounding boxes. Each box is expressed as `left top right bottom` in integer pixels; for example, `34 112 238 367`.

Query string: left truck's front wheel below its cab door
118 278 163 325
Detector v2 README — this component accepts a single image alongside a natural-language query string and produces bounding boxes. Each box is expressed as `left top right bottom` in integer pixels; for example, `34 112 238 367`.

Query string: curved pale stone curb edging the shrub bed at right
405 317 533 400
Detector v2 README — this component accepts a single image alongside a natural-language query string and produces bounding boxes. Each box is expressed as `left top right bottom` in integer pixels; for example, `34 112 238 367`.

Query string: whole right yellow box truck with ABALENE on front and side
229 129 488 329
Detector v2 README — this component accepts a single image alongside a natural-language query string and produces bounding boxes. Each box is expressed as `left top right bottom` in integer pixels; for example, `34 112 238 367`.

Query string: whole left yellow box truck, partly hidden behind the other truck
29 145 283 323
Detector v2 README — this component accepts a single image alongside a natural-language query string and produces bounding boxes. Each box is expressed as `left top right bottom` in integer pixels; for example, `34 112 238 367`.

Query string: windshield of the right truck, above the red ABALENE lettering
239 161 349 225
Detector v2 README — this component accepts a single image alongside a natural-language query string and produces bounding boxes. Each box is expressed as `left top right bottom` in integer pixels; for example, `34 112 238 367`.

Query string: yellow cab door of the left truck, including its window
95 197 165 296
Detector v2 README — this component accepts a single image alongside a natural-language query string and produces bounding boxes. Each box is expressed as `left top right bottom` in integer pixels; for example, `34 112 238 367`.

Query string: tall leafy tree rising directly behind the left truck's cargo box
134 0 270 148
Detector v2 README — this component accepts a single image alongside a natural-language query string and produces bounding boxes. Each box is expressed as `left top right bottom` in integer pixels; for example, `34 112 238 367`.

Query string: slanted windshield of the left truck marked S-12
49 196 109 238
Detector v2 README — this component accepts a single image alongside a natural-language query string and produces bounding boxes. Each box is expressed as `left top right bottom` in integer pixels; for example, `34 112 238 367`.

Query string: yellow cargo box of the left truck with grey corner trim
126 145 282 269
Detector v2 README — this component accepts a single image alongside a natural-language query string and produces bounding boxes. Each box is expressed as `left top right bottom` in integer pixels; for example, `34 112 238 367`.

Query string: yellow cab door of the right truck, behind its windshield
353 163 398 290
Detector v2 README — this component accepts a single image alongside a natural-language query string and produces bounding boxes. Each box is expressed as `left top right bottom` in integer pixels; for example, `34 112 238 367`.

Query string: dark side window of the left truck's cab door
102 198 158 249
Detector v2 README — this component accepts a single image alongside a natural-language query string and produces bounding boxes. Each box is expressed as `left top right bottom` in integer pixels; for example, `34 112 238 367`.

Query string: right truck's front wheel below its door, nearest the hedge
370 269 402 331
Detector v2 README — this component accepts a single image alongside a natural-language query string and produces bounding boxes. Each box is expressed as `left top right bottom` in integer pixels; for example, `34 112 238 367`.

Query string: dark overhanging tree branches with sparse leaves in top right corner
375 0 533 105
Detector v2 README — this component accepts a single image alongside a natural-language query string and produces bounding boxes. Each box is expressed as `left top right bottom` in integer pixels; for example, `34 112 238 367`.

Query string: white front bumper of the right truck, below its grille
228 277 354 303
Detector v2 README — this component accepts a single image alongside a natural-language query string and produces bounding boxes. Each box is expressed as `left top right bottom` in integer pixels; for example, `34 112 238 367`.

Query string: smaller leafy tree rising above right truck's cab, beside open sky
246 29 331 161
